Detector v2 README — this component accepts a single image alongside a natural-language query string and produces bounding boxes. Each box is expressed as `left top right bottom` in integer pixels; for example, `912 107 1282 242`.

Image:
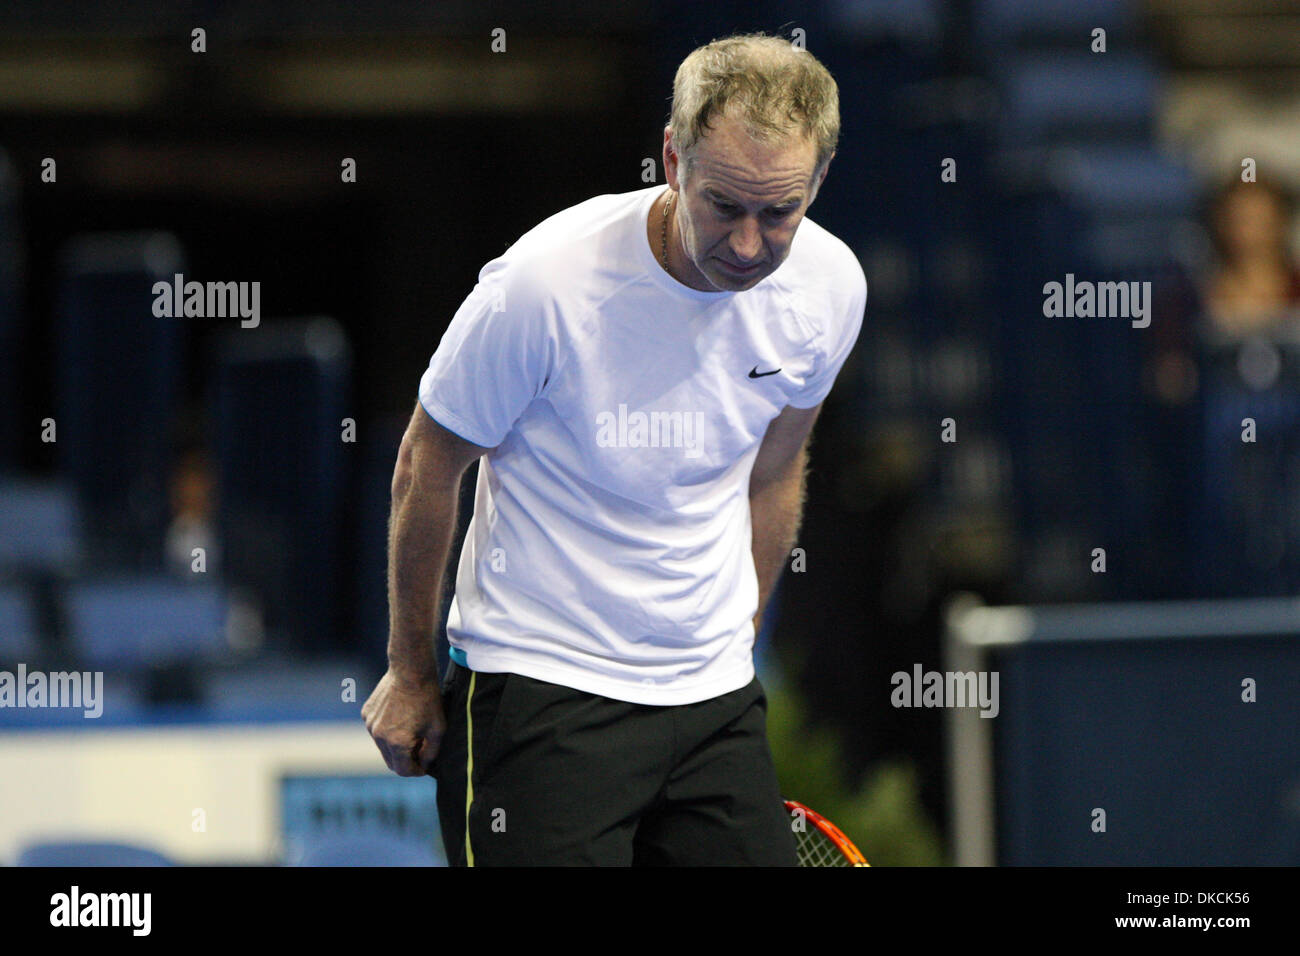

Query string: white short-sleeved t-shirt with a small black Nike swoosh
420 186 867 705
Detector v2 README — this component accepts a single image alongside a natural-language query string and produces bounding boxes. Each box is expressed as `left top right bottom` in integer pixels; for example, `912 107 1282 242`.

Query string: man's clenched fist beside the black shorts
361 670 447 777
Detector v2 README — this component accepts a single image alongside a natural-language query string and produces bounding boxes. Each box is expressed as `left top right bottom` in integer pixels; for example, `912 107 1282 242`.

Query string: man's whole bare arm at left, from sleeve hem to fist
361 403 490 777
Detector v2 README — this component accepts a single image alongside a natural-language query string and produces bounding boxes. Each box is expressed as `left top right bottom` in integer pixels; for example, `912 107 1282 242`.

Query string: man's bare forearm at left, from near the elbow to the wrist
389 466 460 684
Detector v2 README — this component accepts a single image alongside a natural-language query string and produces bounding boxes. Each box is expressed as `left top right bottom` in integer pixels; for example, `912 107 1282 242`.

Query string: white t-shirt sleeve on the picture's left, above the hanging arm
420 259 555 447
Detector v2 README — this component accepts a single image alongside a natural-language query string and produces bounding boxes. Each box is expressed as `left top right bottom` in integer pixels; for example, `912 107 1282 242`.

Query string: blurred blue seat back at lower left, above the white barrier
64 576 226 670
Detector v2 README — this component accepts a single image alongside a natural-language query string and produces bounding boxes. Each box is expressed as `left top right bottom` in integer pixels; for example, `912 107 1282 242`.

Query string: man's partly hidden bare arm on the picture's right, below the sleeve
749 405 822 633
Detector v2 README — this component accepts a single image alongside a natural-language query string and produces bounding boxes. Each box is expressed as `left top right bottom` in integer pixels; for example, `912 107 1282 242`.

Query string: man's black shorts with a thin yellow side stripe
433 662 797 866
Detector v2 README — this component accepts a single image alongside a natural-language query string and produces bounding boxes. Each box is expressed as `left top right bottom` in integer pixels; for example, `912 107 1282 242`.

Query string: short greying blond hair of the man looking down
668 33 840 184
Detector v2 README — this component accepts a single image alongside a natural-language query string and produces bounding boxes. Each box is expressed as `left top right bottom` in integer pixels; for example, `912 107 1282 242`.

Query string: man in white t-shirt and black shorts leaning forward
361 35 867 865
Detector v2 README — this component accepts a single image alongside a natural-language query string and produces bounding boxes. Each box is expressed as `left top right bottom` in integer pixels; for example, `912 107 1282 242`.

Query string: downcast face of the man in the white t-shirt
664 116 829 293
